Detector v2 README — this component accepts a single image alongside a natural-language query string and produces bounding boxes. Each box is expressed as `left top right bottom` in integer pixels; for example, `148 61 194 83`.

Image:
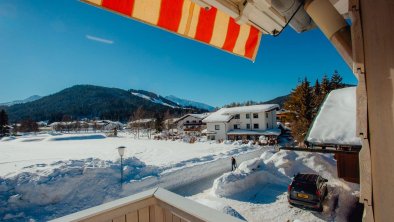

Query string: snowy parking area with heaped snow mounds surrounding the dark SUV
189 150 359 221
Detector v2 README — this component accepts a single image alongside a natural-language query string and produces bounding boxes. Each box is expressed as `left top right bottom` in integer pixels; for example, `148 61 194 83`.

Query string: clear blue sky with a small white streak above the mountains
0 0 357 106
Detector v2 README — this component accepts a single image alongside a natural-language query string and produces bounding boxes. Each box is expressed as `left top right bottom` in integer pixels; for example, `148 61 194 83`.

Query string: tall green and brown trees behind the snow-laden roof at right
284 71 346 144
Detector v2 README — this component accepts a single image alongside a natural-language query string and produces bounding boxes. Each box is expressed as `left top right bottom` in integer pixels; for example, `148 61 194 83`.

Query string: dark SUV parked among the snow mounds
287 173 327 211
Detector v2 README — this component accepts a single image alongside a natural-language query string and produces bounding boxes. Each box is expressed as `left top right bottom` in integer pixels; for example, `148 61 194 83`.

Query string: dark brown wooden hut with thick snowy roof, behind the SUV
306 87 361 183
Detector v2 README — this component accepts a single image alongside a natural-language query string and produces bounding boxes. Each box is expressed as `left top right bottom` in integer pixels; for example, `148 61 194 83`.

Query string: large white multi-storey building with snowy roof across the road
202 104 280 140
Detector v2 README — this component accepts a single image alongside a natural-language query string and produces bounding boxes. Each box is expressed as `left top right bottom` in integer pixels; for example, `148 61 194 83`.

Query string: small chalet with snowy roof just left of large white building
174 113 209 133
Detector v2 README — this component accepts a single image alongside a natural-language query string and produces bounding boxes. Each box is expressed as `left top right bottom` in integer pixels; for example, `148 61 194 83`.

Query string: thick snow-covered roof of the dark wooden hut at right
307 87 361 146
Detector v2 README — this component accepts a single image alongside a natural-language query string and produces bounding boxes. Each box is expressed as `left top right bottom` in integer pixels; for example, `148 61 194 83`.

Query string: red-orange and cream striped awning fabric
82 0 262 61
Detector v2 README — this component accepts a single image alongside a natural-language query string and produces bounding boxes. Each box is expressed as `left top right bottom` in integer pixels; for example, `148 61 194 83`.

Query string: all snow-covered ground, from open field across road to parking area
0 134 359 221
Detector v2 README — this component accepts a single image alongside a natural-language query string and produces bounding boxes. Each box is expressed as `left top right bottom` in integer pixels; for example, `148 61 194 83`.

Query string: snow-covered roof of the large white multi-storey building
203 104 279 123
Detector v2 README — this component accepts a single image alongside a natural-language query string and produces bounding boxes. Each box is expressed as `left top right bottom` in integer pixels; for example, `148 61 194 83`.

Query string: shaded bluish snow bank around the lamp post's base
0 157 159 220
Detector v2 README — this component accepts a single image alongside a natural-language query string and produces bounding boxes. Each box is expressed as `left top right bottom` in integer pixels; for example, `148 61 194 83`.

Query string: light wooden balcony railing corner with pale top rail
52 188 242 222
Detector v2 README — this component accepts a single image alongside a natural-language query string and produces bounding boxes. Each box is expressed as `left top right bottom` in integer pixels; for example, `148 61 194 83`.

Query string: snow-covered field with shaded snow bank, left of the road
0 134 258 221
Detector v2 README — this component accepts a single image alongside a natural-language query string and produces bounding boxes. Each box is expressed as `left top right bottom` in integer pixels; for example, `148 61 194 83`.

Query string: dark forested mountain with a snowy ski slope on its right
6 85 206 122
